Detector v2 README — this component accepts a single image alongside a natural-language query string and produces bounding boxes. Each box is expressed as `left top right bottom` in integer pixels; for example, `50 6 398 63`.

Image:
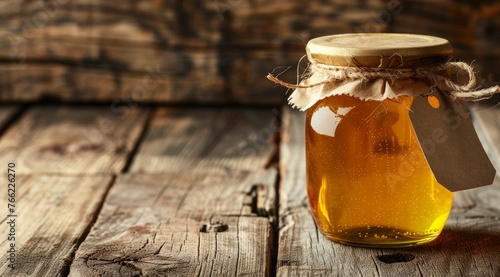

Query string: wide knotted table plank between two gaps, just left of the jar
70 105 279 276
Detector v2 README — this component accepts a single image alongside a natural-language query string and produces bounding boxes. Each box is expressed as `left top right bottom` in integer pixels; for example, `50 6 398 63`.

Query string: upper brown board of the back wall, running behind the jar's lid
0 0 500 64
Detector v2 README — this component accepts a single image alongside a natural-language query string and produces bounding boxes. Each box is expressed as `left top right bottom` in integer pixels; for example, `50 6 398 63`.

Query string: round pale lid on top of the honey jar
307 33 453 68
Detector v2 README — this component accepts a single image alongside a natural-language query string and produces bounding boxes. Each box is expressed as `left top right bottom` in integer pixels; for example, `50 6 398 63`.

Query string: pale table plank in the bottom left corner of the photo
0 174 112 276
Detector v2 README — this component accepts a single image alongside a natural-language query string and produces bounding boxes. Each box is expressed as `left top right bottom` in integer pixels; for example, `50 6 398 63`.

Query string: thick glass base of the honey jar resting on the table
320 226 441 248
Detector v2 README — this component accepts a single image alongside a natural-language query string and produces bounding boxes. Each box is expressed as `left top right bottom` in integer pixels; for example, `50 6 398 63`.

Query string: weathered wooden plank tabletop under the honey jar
0 105 500 276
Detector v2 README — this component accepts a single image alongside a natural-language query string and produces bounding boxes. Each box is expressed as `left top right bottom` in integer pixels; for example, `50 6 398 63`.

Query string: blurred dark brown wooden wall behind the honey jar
0 0 500 105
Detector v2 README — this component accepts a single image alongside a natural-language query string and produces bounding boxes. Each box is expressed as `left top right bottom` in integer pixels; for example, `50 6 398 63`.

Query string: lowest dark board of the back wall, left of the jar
0 61 286 105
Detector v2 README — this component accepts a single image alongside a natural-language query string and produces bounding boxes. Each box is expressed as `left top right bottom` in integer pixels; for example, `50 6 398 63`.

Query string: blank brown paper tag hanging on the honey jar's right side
410 92 496 191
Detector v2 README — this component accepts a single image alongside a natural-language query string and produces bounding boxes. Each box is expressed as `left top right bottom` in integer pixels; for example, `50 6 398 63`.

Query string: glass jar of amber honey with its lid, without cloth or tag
305 34 453 247
